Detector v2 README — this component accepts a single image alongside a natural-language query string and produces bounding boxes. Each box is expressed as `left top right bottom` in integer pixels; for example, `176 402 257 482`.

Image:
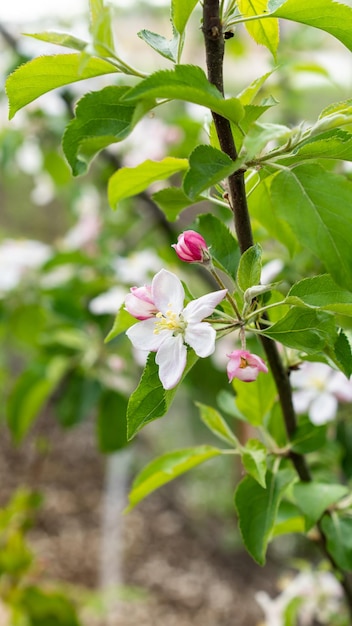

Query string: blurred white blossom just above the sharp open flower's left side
113 250 161 284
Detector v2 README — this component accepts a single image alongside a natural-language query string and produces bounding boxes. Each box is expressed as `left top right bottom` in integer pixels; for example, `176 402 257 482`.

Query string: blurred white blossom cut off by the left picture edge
0 239 52 293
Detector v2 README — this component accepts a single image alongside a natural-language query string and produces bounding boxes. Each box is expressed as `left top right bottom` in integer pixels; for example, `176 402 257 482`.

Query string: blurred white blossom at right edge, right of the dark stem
291 362 352 426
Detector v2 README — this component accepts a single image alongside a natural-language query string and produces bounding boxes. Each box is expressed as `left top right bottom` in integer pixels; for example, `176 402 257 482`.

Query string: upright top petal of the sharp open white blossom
152 269 185 315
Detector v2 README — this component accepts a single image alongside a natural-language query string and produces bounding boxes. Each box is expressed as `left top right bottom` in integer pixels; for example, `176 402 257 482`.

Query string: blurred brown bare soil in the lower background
0 414 279 626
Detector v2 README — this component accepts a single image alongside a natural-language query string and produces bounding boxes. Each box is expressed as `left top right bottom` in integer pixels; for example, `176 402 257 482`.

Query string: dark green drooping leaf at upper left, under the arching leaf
62 87 154 176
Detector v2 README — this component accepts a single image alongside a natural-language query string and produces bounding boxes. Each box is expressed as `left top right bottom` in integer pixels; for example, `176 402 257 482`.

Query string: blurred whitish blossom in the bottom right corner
255 572 342 626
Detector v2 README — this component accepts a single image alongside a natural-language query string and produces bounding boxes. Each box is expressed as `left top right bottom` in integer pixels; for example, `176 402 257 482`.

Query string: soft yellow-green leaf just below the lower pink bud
233 372 277 426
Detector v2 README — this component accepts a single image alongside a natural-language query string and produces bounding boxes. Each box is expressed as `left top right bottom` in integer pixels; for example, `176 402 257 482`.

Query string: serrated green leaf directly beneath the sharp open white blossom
127 350 198 439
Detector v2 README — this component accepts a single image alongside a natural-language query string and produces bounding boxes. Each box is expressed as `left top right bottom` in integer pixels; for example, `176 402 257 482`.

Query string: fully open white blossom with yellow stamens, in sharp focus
126 269 227 389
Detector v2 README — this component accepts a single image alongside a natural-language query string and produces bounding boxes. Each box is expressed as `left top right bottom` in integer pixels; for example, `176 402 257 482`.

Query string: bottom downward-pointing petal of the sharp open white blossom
155 335 187 389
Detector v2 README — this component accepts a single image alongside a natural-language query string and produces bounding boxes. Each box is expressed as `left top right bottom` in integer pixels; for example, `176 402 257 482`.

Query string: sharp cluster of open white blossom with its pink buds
125 230 268 389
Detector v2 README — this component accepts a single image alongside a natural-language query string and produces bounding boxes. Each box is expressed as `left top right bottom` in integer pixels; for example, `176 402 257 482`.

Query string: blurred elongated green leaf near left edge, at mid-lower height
7 356 69 444
